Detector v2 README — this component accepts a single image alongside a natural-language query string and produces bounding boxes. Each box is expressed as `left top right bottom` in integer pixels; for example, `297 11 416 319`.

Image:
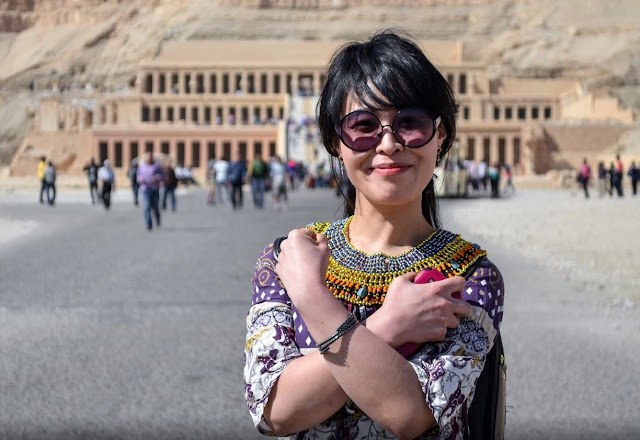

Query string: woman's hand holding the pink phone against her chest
367 272 471 348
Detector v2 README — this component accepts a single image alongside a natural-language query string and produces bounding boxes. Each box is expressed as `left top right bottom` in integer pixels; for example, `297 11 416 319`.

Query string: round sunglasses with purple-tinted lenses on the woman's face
337 107 440 151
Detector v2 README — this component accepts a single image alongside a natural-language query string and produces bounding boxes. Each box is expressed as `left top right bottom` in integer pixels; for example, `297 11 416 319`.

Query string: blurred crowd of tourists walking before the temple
37 152 640 220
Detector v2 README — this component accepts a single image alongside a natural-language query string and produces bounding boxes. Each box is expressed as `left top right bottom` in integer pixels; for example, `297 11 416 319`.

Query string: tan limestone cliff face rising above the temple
0 0 640 164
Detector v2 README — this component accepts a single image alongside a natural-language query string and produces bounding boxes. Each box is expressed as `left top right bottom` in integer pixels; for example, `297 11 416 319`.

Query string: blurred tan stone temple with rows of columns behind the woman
10 40 634 182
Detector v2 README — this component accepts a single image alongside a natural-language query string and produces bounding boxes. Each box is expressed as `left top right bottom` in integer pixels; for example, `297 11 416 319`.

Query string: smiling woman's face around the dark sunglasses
338 97 447 211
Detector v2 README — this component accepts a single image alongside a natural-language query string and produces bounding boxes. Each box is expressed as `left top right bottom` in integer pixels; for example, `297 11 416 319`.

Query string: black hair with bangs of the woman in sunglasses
316 29 458 228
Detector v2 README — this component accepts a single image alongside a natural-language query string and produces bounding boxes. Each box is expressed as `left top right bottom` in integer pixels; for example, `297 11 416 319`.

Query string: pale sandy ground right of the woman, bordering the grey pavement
444 189 640 308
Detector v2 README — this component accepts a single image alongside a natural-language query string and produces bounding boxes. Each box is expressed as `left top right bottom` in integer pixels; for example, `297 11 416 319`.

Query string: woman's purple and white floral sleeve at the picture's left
244 244 302 436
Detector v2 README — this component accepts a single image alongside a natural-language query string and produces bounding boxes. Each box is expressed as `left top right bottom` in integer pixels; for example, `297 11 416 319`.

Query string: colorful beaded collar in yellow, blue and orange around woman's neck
308 217 487 306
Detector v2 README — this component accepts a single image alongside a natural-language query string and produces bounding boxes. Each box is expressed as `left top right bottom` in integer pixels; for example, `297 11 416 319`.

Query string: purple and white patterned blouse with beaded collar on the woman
244 218 504 439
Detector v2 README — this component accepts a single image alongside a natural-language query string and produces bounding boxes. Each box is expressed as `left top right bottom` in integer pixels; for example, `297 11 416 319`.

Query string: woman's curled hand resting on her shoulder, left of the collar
276 228 329 305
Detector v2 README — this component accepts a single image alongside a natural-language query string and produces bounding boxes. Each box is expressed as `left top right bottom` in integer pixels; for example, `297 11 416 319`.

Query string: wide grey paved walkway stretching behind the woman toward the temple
0 189 640 440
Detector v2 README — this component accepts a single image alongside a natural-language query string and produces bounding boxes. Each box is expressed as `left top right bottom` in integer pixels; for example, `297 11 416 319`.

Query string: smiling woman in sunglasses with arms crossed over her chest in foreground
244 31 504 439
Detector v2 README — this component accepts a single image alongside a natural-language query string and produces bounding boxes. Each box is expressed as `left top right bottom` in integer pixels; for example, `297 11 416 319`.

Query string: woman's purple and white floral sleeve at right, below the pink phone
410 258 504 438
